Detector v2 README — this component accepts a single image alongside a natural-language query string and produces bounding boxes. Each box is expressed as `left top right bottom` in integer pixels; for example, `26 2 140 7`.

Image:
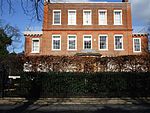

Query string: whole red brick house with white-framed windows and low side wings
24 0 148 56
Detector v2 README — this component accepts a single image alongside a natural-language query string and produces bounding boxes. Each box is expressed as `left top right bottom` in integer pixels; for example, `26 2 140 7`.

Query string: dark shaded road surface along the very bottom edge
0 103 150 113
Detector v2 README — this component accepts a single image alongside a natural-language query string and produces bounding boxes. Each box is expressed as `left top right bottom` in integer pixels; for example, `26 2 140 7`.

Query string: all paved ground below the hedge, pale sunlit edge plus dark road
0 98 150 113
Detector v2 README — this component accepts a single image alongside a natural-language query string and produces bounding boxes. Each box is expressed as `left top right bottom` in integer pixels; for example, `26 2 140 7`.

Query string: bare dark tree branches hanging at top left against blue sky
0 0 44 21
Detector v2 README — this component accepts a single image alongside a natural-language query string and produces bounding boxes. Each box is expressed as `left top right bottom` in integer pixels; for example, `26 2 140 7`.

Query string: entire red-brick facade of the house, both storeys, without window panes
25 0 147 56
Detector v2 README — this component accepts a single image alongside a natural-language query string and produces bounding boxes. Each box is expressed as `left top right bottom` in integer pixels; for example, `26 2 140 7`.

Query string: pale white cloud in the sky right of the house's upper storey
130 0 150 23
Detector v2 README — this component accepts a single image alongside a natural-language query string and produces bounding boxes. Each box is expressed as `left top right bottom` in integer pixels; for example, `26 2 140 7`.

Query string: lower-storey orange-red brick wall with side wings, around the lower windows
25 31 147 56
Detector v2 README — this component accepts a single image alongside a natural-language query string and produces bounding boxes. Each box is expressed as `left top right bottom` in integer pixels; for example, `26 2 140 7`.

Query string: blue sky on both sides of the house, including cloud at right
0 0 150 52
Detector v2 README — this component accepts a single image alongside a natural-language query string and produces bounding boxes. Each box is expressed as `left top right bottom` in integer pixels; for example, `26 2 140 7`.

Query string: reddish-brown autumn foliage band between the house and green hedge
23 54 150 73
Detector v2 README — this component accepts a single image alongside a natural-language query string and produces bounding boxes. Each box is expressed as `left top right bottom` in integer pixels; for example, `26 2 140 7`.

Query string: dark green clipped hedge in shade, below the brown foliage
6 72 150 98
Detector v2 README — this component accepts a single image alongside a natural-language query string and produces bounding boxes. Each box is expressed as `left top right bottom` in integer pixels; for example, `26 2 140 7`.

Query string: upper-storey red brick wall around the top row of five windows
43 2 132 31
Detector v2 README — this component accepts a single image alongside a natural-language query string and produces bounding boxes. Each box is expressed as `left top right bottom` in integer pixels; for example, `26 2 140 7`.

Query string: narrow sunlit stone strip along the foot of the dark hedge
0 97 150 105
